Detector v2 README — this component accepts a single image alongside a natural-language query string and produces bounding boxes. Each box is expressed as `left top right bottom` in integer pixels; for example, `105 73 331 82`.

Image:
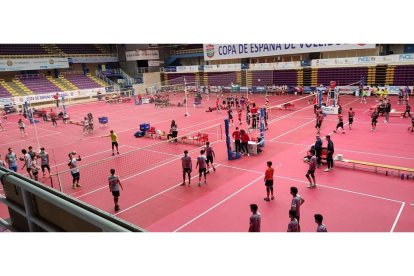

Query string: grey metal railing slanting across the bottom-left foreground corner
0 168 145 232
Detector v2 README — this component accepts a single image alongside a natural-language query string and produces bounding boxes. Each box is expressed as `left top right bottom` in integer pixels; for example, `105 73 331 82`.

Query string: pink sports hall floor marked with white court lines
0 95 414 232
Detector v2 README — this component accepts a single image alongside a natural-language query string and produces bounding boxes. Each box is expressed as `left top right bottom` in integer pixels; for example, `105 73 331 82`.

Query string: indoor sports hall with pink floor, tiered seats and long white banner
0 44 414 232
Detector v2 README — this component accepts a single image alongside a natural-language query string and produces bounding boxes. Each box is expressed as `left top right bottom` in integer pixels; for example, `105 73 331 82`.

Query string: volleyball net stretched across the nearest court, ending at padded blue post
51 124 223 194
